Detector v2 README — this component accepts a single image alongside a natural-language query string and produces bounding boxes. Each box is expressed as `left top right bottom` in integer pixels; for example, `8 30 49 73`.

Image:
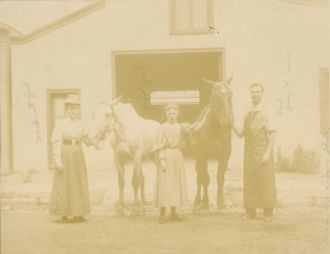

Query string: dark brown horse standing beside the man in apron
192 78 233 209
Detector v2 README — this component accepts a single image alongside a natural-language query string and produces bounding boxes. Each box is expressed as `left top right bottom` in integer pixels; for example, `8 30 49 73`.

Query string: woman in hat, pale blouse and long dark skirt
50 95 90 222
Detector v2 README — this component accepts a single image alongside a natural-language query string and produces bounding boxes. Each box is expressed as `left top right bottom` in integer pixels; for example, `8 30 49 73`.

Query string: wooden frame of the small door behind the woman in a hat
46 88 81 168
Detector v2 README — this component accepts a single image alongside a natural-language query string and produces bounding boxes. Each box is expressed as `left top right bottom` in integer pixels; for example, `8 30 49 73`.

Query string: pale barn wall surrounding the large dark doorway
8 0 330 170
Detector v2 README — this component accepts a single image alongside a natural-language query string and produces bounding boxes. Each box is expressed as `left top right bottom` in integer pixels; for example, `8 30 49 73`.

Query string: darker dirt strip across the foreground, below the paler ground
1 208 330 254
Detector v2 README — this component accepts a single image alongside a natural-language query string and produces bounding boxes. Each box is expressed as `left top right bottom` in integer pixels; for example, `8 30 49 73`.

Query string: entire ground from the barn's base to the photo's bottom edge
1 162 330 254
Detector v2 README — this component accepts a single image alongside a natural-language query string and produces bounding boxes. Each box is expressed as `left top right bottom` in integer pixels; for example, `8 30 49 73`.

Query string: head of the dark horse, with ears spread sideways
203 77 233 128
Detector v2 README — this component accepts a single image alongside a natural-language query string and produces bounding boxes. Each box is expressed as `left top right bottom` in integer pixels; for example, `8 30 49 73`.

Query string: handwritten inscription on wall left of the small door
22 82 42 143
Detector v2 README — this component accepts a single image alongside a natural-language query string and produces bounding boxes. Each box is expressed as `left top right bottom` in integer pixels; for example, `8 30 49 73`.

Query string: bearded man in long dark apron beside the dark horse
234 83 276 220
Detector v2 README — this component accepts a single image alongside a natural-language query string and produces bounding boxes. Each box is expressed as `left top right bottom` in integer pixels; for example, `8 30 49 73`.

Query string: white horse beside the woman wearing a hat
88 97 165 209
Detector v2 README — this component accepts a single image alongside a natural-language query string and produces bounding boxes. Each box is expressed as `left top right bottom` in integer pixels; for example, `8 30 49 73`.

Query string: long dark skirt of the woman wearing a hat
50 145 90 216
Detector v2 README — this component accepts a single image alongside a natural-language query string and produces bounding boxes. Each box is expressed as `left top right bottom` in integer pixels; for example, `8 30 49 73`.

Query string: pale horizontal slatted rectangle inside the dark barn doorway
150 90 200 105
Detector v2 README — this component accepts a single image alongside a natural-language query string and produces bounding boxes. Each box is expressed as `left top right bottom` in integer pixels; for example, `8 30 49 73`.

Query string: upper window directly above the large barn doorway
170 0 214 34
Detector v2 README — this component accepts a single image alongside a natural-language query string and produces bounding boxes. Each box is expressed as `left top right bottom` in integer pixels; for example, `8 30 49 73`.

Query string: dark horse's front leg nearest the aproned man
217 141 231 209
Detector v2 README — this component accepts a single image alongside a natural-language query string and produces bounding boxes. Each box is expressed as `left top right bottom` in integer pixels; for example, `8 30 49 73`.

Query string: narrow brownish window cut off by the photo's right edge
319 68 330 133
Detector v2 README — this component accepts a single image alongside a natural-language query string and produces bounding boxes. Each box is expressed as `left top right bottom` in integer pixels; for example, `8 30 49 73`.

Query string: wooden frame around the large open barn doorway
111 48 226 99
